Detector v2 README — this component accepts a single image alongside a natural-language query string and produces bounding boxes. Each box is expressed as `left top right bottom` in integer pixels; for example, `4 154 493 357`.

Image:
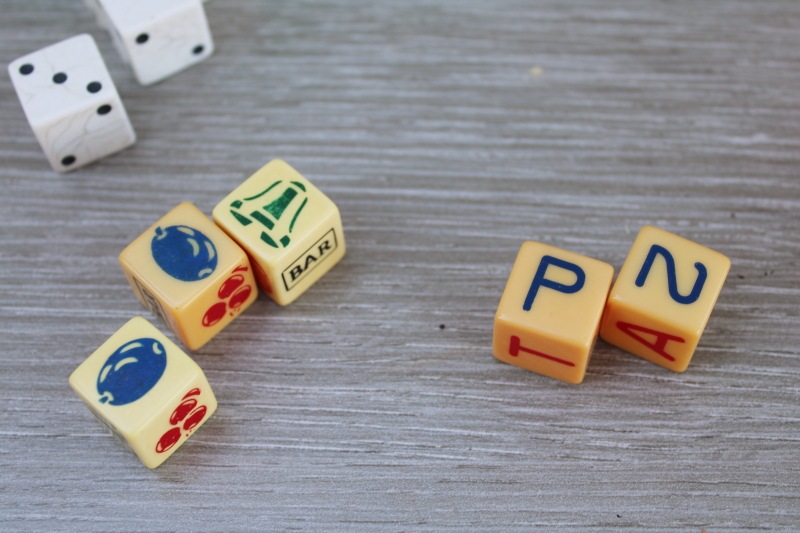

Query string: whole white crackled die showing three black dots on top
8 34 136 172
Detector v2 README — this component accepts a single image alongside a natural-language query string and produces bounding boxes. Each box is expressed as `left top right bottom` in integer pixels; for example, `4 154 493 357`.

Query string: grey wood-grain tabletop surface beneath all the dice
0 0 800 533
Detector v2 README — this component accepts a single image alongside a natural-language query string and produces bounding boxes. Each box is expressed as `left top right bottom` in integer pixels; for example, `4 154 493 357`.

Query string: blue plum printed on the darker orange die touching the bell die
150 226 217 281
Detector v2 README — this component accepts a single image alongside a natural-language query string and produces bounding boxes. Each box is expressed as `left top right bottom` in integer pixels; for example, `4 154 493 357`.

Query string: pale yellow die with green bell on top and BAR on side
213 159 345 305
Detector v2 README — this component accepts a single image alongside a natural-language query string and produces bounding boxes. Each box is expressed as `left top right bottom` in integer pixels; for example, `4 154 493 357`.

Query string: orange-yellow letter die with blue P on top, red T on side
492 241 614 383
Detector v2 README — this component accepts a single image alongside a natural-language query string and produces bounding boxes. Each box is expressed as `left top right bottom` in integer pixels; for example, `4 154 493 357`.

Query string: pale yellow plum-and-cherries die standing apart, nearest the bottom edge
69 317 217 468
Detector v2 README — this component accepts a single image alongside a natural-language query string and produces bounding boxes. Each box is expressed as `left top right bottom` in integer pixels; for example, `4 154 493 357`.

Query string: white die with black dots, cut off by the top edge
84 0 214 85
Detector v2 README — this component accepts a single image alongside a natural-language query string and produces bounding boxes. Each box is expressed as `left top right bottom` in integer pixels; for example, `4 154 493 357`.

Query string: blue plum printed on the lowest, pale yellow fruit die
97 338 167 405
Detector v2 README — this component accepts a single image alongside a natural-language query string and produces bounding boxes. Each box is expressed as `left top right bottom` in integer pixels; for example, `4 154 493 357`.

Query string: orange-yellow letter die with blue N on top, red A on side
600 226 731 372
